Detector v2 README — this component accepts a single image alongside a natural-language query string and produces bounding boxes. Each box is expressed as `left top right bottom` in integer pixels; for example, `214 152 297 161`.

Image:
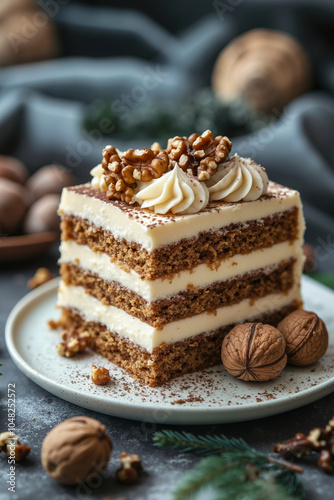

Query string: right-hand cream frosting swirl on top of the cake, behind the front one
207 154 269 202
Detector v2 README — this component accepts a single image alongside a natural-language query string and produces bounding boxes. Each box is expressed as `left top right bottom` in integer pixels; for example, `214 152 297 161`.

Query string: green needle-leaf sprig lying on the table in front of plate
153 430 305 500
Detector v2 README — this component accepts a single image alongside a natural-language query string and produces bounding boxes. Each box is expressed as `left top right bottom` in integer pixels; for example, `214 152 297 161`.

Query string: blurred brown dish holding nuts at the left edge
0 231 59 262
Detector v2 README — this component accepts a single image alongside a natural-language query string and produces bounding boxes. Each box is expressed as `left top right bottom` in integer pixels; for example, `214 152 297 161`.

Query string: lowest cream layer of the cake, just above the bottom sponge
58 282 300 352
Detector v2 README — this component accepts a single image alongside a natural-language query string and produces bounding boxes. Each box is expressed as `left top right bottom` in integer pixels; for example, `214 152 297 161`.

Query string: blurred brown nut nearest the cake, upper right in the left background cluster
26 165 75 199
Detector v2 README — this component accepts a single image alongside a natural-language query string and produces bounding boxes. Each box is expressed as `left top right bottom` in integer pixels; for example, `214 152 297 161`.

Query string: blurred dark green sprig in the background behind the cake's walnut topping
83 88 268 144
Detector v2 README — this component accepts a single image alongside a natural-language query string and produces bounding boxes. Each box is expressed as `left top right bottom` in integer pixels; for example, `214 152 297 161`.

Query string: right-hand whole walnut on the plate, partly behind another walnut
277 310 328 366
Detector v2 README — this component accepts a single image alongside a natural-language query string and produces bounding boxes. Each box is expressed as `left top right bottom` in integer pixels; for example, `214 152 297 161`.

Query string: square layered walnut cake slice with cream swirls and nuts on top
58 131 304 386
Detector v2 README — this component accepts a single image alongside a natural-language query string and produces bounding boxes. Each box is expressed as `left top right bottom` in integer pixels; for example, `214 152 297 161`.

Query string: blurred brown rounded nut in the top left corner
0 0 59 66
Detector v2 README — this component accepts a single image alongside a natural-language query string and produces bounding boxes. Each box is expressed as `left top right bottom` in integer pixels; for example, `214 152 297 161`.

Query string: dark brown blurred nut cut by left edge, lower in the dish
0 178 29 233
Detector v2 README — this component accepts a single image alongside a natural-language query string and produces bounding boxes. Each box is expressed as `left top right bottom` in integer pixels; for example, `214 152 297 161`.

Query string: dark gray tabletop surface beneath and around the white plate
0 244 334 500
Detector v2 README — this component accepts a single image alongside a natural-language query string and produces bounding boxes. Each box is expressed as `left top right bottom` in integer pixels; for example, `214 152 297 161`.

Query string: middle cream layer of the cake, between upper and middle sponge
59 240 301 302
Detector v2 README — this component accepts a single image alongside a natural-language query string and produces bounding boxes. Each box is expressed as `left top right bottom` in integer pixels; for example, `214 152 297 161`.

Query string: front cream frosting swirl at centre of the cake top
135 164 209 214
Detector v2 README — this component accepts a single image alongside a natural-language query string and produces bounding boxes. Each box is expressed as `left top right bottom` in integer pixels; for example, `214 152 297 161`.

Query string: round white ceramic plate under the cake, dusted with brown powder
6 278 334 424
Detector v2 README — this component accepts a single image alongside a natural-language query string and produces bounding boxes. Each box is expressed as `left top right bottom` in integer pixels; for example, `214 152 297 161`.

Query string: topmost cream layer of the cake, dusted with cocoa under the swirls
59 183 304 251
